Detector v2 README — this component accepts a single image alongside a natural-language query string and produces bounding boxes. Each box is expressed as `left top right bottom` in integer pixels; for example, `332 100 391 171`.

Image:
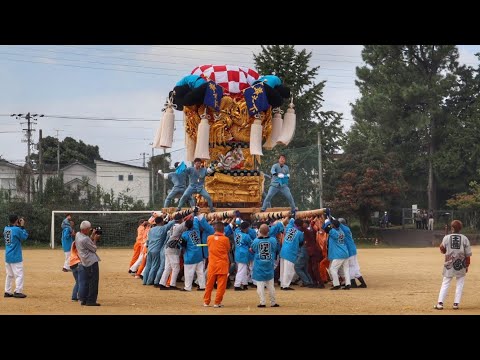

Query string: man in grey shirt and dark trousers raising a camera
75 220 102 306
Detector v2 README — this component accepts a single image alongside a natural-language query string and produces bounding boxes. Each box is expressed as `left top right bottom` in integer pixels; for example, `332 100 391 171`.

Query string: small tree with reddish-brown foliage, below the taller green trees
327 122 407 235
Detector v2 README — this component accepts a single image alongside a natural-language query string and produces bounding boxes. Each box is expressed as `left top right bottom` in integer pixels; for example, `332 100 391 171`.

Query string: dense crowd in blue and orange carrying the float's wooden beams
124 209 367 307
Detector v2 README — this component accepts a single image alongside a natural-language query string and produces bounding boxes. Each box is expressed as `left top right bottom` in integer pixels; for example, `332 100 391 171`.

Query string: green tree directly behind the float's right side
254 45 343 209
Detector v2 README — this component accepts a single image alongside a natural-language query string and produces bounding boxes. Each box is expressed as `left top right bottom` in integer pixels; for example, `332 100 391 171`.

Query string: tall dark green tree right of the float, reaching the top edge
352 45 459 209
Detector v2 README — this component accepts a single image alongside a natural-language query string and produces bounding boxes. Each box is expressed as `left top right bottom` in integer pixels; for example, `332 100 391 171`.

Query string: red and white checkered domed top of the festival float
192 65 260 94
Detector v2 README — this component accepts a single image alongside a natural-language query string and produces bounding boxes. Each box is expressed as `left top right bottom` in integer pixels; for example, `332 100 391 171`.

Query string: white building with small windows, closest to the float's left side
95 160 150 203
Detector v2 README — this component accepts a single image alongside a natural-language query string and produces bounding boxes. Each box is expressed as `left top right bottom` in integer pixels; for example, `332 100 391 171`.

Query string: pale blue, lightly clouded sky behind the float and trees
0 45 480 165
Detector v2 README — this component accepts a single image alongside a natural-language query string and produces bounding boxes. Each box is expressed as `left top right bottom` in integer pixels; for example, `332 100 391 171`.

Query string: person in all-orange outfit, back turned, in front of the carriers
203 232 230 305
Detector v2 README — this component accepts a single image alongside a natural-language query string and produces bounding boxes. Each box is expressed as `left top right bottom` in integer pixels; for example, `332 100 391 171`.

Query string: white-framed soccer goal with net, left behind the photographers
50 210 153 249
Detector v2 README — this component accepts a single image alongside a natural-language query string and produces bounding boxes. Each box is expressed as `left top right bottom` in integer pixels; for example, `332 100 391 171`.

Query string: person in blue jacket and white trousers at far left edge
3 215 28 299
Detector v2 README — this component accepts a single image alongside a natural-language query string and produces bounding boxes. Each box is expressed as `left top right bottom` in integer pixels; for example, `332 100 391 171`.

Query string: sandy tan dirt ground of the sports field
0 246 480 315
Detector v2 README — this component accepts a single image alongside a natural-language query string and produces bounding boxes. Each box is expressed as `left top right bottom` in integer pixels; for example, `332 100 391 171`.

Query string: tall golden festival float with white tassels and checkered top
154 65 323 220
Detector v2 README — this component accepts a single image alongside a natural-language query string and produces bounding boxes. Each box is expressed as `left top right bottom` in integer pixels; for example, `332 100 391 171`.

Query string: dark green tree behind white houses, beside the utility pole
31 136 102 170
